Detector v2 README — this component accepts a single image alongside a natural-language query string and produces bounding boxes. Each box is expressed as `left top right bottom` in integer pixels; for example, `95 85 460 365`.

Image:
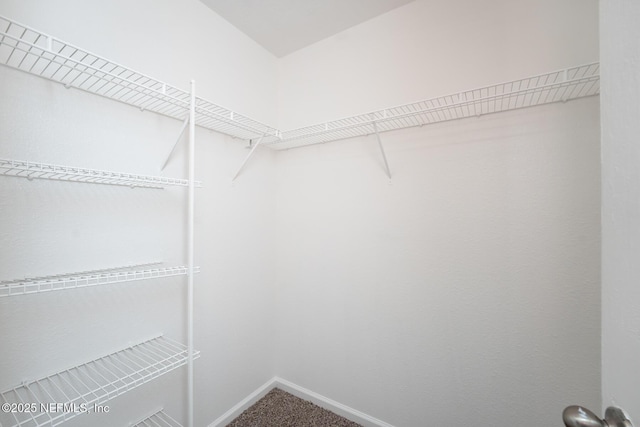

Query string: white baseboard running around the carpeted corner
209 377 393 427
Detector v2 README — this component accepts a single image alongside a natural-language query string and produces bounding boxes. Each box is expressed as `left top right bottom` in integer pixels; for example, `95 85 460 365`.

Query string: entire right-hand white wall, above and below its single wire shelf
276 0 601 427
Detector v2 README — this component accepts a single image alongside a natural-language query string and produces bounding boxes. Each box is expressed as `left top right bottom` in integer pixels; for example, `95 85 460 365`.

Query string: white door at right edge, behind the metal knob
600 0 640 425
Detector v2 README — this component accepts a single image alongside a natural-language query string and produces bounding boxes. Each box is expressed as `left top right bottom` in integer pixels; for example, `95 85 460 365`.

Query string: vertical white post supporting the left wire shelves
187 80 196 427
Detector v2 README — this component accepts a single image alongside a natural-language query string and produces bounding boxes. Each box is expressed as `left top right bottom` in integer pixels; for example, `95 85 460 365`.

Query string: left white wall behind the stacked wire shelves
0 0 277 426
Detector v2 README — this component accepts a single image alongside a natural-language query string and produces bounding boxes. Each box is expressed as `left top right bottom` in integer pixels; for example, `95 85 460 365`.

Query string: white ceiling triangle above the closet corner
200 0 414 58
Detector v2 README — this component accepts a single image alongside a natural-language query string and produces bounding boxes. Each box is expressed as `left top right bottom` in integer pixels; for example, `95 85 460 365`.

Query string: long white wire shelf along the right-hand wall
264 62 600 149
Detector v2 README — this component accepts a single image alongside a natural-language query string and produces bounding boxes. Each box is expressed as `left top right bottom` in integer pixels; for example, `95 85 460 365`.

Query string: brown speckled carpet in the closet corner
227 388 362 427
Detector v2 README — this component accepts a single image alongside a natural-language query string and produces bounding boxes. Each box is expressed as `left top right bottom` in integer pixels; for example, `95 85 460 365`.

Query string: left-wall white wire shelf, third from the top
0 263 200 298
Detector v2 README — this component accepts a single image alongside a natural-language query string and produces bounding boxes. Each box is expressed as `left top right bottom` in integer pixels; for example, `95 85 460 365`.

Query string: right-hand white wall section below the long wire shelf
276 98 600 427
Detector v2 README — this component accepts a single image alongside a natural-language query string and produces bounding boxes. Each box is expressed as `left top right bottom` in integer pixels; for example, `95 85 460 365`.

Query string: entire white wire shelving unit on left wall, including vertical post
0 12 205 427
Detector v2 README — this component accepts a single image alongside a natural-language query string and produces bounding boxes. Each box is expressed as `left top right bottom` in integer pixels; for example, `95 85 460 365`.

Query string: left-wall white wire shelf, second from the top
0 159 202 189
